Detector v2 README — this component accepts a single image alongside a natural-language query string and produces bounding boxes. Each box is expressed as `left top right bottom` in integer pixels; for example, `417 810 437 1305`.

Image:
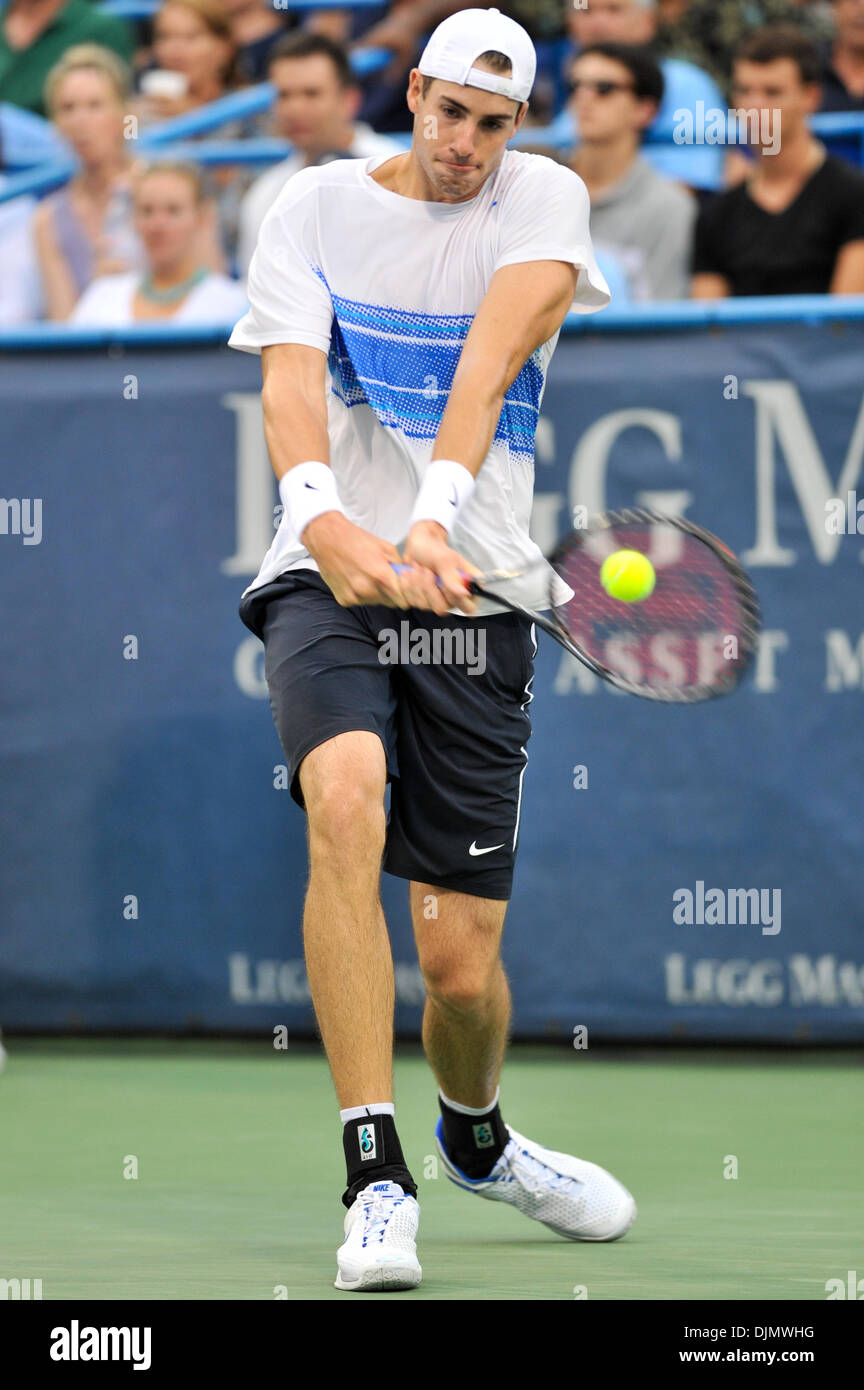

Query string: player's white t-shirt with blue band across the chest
231 150 610 613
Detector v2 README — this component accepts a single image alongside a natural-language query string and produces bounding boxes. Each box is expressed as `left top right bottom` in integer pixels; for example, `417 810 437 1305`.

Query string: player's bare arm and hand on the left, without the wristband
261 343 407 607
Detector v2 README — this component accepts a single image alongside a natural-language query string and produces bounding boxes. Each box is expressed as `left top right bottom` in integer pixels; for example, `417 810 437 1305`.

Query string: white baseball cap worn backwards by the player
417 10 538 101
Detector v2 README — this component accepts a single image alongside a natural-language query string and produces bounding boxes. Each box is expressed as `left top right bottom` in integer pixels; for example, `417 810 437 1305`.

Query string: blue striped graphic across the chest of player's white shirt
315 270 543 459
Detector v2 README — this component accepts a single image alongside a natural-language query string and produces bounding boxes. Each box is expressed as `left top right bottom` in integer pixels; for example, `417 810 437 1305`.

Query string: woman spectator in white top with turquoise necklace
69 163 247 328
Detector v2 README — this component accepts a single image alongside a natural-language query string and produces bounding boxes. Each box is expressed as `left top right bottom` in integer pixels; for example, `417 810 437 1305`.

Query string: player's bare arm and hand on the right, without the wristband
404 261 576 612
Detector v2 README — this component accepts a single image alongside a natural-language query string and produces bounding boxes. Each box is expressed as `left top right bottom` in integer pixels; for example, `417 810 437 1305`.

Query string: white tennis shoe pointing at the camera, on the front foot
335 1183 422 1293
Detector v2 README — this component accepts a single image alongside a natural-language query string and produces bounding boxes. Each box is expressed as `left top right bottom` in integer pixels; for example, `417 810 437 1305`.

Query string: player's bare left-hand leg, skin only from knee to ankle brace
300 731 393 1109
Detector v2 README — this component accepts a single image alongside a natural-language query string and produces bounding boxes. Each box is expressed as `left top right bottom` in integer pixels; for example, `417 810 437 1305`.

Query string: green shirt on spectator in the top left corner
0 0 135 115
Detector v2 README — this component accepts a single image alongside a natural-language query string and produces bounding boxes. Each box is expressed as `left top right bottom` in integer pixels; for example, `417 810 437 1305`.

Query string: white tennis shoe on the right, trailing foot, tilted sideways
435 1119 636 1240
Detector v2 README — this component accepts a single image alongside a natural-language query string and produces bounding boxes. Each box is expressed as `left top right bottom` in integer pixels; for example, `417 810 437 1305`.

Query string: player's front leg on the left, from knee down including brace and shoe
300 731 421 1291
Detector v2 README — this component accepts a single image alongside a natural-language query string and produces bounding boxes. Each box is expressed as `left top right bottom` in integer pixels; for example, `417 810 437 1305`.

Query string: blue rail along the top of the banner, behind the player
0 295 864 352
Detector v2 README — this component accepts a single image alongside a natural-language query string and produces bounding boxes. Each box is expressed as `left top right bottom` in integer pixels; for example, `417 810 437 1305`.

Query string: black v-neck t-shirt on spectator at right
693 154 864 295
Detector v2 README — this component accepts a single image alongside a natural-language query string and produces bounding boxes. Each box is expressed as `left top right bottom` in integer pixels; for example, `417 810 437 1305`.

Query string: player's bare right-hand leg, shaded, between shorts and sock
411 883 510 1109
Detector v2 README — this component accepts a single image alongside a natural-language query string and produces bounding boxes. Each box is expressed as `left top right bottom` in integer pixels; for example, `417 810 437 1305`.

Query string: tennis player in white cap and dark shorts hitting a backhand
231 10 636 1290
